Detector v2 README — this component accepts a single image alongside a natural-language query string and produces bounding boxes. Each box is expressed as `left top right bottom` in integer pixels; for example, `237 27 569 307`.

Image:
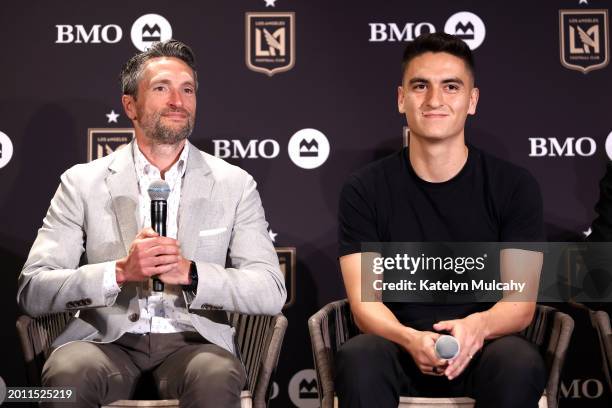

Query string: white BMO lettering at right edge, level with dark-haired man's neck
529 137 597 157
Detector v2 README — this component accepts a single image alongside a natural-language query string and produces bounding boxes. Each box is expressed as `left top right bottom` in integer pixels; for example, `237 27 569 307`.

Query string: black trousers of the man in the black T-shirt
335 334 546 408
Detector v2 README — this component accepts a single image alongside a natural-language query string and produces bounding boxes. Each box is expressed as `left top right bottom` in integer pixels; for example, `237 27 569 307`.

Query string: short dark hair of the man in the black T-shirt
402 33 476 80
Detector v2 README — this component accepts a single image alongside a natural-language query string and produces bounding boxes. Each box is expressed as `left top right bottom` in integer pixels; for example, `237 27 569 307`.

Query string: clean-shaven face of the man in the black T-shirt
397 52 478 142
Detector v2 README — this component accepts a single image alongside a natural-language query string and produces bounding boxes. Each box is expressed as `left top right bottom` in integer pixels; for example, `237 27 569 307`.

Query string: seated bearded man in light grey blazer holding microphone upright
17 40 286 407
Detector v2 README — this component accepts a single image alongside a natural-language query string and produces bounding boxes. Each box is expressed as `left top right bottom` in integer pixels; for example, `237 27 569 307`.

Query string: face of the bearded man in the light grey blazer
124 57 196 144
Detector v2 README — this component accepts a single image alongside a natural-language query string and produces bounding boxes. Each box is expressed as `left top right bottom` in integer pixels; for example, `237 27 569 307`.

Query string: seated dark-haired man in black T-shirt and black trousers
335 33 555 408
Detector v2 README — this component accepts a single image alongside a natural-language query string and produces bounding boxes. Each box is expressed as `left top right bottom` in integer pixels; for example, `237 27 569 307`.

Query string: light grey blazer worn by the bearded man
17 142 286 352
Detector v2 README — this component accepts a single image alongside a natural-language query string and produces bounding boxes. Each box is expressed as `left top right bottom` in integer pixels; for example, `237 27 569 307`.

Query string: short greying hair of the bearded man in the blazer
119 39 198 98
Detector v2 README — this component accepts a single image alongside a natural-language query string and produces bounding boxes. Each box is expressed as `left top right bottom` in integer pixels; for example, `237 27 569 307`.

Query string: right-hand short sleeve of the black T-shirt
500 170 546 245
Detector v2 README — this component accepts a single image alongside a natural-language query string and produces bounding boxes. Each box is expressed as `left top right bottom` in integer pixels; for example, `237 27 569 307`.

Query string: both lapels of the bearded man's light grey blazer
106 141 215 259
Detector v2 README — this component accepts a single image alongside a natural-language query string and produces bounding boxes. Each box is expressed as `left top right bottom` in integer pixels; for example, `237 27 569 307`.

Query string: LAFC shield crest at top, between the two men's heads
245 13 295 76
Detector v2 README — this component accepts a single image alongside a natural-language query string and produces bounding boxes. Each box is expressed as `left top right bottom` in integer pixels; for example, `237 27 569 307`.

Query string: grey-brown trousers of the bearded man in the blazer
41 332 246 408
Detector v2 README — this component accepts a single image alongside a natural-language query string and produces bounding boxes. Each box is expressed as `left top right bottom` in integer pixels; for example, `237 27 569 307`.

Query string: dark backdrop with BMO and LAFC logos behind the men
0 0 612 407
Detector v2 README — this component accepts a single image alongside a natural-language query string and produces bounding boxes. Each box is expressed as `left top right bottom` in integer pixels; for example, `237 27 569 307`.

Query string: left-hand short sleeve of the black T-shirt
338 176 379 256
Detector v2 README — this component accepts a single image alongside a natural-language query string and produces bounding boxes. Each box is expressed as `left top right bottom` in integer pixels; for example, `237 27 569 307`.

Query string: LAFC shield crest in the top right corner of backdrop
559 10 610 74
